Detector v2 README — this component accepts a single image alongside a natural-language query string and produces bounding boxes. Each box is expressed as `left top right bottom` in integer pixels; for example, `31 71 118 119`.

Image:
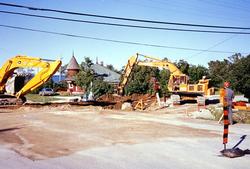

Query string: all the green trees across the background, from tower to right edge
40 53 250 98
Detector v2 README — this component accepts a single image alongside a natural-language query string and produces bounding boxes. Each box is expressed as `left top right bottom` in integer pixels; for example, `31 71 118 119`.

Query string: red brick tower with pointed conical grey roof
65 54 83 94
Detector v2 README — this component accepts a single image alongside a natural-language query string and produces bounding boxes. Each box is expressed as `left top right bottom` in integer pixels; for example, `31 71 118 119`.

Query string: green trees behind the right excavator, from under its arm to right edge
125 53 250 98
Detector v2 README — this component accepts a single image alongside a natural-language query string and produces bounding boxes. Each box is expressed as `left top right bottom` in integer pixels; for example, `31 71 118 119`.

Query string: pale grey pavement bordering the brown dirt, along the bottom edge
0 110 250 169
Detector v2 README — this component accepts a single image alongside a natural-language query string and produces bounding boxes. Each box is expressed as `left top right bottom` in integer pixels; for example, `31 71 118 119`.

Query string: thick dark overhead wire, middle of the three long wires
0 10 250 35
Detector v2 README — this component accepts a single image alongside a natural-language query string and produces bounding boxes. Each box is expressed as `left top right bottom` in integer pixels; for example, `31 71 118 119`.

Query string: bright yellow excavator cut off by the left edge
0 56 61 105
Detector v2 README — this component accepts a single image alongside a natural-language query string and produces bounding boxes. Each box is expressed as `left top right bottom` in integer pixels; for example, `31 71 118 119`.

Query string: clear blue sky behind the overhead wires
0 0 250 69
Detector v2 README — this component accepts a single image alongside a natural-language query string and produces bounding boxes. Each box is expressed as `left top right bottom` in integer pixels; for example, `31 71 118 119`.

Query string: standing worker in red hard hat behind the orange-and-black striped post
224 81 234 125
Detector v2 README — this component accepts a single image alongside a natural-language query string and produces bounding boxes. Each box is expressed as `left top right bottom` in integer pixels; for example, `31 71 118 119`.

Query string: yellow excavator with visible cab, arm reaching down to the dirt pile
118 53 214 100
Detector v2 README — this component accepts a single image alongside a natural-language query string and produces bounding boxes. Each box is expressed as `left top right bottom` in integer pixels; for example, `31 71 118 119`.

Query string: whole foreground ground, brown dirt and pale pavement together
0 104 250 169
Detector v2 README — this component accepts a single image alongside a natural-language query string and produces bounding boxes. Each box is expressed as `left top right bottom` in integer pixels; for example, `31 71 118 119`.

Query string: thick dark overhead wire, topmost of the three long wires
0 2 250 30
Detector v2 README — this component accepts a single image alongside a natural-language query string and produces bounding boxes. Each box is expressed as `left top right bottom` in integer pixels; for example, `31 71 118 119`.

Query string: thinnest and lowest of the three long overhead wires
0 24 248 54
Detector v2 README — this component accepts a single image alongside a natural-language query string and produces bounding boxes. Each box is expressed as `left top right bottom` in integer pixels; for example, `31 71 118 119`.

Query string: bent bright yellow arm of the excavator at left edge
0 56 61 98
